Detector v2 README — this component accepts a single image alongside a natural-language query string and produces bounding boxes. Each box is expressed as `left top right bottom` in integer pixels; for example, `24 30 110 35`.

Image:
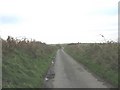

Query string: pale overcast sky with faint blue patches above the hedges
0 0 119 43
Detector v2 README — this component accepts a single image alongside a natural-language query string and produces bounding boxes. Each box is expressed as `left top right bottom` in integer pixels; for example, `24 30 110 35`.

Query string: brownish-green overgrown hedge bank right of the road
65 43 120 86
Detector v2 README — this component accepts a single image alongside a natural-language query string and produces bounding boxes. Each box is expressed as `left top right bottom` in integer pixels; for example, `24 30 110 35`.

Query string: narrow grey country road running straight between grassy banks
53 49 110 88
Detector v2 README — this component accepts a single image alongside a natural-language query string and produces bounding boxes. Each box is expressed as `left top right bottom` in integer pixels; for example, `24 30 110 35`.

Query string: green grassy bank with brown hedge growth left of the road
2 37 57 88
